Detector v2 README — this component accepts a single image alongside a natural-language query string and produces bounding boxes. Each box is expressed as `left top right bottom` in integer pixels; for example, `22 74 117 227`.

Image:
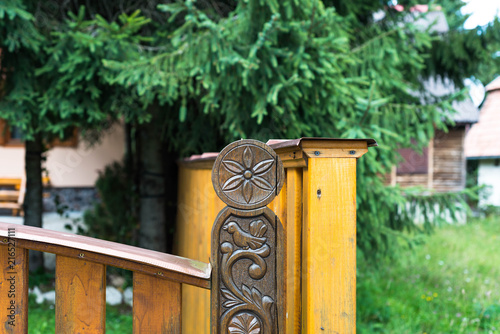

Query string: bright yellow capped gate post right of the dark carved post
268 138 377 334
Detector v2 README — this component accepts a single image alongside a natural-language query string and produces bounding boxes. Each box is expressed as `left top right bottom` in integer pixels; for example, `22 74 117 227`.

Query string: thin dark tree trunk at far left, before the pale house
24 135 43 271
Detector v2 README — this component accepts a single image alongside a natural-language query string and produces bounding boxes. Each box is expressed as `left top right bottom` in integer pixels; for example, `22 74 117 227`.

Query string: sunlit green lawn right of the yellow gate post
357 217 500 334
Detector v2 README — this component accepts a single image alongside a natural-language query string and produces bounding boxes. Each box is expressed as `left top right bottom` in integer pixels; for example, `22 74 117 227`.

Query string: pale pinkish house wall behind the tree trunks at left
0 125 125 187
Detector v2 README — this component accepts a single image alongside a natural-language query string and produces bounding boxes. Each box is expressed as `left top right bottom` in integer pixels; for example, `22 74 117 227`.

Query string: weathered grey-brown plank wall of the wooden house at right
432 127 466 192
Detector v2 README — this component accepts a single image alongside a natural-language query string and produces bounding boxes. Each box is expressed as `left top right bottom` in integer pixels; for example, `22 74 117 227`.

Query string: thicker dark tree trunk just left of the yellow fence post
139 104 167 252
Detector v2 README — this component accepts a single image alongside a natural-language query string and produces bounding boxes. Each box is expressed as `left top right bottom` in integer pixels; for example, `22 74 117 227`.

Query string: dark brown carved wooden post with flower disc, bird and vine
211 140 285 334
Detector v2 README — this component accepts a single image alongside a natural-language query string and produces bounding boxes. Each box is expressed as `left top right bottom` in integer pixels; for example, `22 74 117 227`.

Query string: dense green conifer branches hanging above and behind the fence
0 0 498 257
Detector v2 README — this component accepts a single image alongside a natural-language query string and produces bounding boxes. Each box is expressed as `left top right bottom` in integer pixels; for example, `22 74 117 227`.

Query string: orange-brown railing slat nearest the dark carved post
133 273 181 334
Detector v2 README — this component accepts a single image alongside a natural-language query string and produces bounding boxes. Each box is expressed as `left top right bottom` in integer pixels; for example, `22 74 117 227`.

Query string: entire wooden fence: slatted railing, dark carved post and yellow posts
0 138 376 334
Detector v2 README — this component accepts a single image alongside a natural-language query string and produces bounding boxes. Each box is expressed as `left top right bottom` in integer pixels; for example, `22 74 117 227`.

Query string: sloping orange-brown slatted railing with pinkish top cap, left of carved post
0 223 211 334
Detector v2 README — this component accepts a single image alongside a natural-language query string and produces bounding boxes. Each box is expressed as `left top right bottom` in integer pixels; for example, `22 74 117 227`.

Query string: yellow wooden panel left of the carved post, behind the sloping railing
175 165 225 334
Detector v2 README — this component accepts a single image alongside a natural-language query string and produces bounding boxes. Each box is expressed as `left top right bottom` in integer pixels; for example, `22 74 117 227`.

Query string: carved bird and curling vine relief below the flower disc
220 219 275 334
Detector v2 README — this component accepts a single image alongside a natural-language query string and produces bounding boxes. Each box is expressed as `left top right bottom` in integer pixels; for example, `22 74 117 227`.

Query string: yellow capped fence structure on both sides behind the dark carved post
176 138 377 334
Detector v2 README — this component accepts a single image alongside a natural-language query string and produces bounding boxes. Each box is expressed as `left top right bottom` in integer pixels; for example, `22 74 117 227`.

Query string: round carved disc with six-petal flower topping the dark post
212 139 284 210
